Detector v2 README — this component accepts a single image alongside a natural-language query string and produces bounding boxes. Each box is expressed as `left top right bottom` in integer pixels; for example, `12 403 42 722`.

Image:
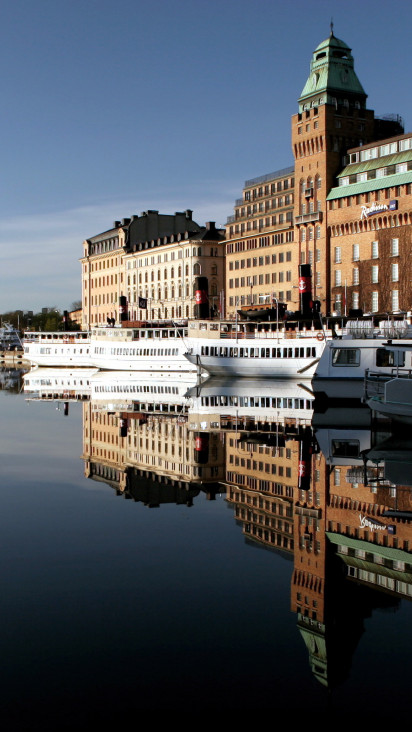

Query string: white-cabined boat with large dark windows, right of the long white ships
312 320 412 398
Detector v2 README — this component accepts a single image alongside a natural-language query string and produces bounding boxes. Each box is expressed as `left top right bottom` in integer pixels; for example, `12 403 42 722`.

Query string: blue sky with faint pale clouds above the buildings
0 0 412 313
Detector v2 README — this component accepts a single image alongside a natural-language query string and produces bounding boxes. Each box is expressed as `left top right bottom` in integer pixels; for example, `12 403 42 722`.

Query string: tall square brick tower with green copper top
292 28 374 314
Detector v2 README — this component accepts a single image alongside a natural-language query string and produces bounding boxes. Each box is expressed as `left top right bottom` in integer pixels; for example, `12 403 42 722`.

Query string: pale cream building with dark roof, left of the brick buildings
81 209 224 329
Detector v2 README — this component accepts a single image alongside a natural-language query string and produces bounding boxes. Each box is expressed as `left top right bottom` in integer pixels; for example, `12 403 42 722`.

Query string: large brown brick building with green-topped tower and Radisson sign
226 31 410 317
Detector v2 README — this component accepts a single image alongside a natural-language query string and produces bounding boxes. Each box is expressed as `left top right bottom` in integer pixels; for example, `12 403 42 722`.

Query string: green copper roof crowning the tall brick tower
299 33 366 107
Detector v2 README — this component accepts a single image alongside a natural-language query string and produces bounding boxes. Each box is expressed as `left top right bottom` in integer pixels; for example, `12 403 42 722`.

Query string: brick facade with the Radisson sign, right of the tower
327 134 412 315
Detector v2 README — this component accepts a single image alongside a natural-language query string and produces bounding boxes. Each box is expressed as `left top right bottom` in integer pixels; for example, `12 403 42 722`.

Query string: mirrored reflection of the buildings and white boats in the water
25 369 412 688
